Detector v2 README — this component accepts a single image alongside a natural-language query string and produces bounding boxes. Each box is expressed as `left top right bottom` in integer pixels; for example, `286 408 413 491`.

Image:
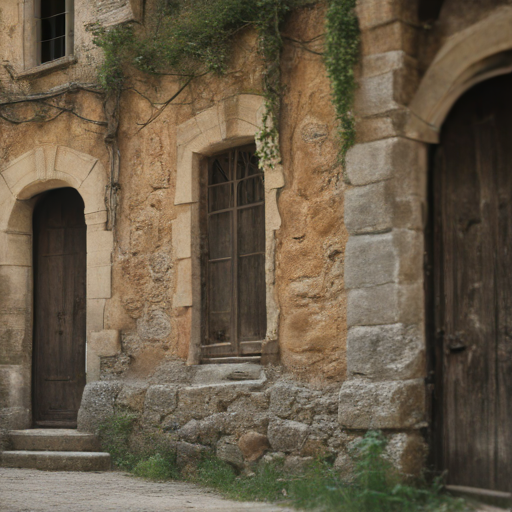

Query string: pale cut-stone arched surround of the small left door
0 145 116 429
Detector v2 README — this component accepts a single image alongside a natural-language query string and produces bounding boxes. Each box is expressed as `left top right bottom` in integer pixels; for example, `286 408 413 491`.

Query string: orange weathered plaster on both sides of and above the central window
99 7 345 381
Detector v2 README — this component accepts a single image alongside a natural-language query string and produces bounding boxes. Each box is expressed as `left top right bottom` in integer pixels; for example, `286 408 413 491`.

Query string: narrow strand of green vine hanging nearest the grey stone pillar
325 0 359 161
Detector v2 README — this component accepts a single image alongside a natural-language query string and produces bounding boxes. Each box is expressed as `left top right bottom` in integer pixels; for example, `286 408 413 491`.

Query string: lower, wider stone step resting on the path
0 450 110 471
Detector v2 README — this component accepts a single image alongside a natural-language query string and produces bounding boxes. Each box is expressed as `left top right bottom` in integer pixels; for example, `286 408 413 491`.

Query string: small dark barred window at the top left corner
35 0 73 64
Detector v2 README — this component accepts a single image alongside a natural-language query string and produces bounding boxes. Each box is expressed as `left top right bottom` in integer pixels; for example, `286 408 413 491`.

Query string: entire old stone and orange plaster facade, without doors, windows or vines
0 0 512 486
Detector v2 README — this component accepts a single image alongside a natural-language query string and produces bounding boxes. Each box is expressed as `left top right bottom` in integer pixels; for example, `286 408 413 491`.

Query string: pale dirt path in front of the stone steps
0 468 292 512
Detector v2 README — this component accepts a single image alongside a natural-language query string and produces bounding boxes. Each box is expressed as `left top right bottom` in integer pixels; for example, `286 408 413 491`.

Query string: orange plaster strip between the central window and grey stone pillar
276 7 348 381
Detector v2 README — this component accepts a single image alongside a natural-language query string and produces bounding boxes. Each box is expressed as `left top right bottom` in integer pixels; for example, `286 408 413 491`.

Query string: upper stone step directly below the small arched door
9 428 100 452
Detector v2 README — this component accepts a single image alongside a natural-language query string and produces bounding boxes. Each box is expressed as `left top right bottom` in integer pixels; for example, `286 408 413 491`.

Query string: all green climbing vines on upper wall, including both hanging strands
93 0 359 167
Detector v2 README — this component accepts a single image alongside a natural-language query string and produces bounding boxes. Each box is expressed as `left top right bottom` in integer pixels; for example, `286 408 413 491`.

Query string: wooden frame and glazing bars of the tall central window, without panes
199 144 267 363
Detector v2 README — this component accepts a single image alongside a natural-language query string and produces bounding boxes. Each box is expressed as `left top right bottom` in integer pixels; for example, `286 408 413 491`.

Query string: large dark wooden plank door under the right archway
432 75 512 492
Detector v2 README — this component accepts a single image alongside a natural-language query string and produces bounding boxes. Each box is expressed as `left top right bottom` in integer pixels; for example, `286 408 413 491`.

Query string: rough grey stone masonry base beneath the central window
78 362 424 476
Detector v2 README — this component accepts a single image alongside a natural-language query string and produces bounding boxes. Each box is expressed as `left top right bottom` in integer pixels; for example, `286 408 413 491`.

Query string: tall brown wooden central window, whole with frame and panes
202 146 267 362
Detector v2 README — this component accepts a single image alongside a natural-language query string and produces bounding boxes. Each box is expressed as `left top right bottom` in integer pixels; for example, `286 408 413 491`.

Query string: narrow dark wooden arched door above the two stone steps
32 188 86 428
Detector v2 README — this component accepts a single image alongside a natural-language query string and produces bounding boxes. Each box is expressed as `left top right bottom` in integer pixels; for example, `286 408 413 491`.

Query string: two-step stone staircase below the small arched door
0 428 110 471
